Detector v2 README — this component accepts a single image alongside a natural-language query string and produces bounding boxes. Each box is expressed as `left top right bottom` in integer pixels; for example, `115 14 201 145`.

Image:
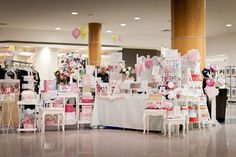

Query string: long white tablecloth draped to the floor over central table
91 95 163 131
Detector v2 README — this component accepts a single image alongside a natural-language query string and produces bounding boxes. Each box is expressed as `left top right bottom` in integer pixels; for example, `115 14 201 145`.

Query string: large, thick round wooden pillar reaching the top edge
171 0 206 68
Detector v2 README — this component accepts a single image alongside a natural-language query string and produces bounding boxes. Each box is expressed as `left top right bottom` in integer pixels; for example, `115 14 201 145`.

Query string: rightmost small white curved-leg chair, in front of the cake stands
163 106 186 138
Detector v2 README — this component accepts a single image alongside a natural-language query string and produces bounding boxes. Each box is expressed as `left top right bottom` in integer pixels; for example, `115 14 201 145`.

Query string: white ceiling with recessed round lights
0 0 236 47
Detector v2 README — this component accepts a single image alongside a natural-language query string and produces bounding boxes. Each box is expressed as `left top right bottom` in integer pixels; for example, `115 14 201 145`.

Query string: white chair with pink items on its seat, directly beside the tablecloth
143 94 167 134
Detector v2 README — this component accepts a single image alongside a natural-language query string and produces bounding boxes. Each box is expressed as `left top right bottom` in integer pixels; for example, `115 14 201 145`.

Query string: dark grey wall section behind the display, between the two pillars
122 48 161 67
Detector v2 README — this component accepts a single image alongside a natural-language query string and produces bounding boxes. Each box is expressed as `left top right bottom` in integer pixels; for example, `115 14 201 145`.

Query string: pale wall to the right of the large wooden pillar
206 33 236 65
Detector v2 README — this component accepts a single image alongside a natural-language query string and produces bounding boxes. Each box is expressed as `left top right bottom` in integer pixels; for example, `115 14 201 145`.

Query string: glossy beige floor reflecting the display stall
0 124 236 157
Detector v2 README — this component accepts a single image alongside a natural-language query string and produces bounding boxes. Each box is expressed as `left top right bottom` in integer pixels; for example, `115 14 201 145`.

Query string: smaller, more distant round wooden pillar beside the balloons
89 23 102 66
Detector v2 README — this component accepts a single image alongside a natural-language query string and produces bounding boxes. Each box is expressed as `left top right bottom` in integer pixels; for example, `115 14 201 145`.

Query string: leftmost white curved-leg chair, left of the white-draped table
38 96 65 133
